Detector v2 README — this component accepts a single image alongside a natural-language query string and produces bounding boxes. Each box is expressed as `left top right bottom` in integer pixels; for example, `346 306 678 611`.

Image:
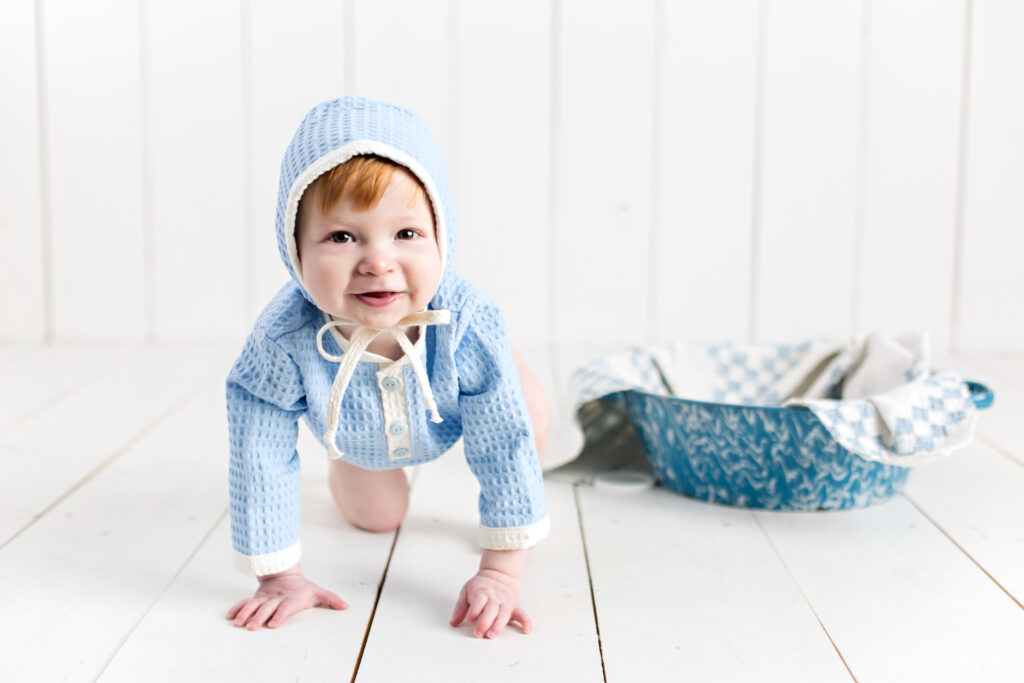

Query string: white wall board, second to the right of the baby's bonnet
552 0 654 344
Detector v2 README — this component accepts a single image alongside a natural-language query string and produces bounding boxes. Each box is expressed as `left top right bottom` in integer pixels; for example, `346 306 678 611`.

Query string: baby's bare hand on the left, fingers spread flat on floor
227 565 348 631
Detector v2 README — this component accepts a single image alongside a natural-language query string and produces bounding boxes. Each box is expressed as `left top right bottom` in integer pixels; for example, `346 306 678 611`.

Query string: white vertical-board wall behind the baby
0 0 1024 354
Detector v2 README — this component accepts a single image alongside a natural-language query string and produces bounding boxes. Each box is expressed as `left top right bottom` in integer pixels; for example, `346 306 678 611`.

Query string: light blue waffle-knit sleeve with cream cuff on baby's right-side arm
456 300 550 550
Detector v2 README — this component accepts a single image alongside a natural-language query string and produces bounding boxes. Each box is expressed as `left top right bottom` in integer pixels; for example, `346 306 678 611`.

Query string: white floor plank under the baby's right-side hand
356 447 602 683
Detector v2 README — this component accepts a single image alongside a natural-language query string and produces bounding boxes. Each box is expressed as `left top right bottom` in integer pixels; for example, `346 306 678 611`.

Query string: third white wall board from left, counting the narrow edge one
146 0 247 341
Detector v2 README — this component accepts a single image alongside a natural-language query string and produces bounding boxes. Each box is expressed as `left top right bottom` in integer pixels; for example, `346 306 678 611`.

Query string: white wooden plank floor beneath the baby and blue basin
0 348 1024 683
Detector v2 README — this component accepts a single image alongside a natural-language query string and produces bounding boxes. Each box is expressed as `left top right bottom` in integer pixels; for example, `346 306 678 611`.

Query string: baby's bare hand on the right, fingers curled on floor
451 569 534 638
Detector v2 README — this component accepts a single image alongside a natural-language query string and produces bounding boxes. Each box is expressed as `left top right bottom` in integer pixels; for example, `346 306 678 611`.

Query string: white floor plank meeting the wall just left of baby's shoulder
0 348 228 547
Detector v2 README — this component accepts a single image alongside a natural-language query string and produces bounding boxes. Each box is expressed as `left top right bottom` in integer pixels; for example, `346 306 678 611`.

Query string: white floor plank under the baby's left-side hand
99 428 393 683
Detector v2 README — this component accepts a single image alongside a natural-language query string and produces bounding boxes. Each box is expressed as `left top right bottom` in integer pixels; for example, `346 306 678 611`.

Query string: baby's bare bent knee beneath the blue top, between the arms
330 460 409 531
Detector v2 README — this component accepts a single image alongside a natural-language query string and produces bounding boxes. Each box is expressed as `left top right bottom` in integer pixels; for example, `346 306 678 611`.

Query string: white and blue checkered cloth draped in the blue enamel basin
569 334 975 466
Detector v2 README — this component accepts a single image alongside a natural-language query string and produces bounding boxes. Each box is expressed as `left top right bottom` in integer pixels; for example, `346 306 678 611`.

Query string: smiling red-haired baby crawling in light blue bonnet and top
221 97 549 638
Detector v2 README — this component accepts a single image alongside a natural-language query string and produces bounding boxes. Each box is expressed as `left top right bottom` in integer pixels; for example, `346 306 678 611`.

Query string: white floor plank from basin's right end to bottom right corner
756 497 1024 682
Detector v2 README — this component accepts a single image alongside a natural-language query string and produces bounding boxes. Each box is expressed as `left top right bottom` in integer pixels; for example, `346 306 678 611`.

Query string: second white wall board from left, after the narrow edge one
41 0 145 341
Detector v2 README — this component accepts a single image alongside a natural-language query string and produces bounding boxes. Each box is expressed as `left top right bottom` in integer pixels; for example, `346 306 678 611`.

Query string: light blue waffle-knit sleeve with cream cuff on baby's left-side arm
226 332 306 577
